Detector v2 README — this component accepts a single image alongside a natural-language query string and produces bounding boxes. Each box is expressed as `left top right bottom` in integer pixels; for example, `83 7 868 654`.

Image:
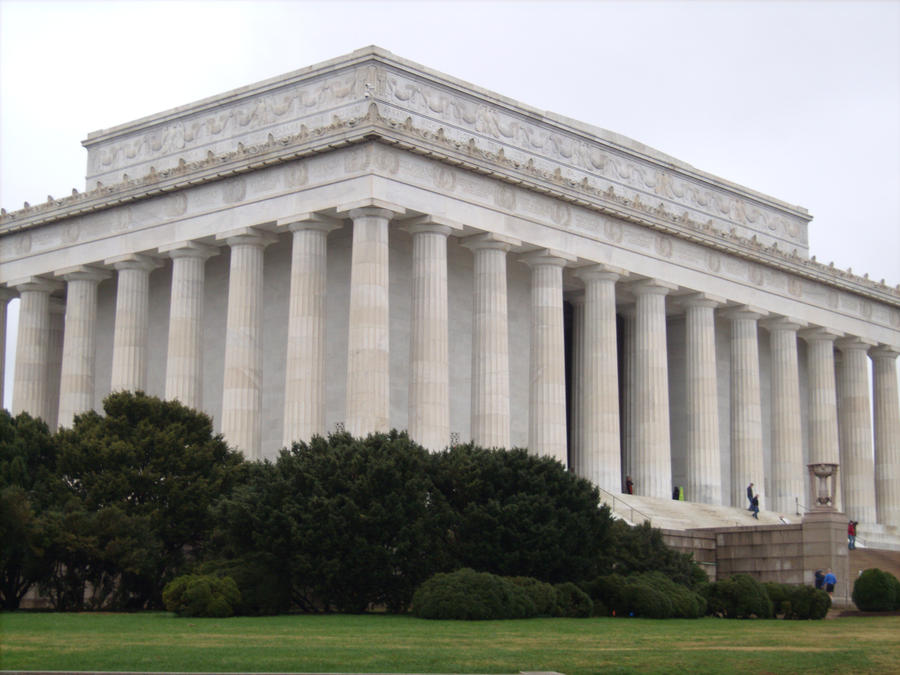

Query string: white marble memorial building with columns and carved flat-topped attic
0 47 900 525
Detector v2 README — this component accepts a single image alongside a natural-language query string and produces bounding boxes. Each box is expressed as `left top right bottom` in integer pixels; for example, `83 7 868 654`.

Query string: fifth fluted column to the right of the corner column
631 279 675 497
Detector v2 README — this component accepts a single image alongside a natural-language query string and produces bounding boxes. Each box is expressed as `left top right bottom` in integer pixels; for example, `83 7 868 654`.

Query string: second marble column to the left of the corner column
216 227 277 459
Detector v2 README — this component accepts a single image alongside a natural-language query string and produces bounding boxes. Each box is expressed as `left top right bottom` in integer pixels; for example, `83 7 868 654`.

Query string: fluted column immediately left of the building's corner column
282 214 341 447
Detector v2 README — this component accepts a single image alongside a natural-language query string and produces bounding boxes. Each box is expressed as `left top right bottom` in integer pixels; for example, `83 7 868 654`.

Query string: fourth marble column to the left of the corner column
106 254 160 392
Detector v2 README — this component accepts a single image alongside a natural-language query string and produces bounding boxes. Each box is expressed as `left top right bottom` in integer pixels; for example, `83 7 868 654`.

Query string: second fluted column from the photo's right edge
837 338 877 523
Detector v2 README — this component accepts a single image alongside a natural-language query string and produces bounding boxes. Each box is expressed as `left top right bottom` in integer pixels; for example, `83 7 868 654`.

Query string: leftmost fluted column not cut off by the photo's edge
10 277 59 422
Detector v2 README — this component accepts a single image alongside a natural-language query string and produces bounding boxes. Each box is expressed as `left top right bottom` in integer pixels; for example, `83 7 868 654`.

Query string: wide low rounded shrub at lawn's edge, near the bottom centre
413 568 537 621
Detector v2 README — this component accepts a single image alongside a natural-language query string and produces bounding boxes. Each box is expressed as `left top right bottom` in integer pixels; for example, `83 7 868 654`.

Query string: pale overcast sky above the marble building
0 0 900 405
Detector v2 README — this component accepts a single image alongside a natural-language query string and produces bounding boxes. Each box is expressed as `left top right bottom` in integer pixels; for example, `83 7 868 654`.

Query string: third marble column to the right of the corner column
522 250 570 466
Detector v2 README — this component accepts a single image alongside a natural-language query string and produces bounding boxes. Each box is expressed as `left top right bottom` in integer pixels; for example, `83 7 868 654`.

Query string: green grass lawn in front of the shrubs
0 612 900 675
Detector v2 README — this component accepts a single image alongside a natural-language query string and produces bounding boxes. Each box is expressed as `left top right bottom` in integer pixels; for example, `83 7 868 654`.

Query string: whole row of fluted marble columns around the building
0 205 900 524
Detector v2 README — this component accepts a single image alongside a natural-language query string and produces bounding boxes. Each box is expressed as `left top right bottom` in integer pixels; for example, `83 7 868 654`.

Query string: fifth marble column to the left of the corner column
56 265 110 427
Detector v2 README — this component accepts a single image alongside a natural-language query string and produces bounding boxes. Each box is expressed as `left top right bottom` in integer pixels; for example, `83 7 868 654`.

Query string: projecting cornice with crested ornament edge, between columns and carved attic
0 101 900 306
